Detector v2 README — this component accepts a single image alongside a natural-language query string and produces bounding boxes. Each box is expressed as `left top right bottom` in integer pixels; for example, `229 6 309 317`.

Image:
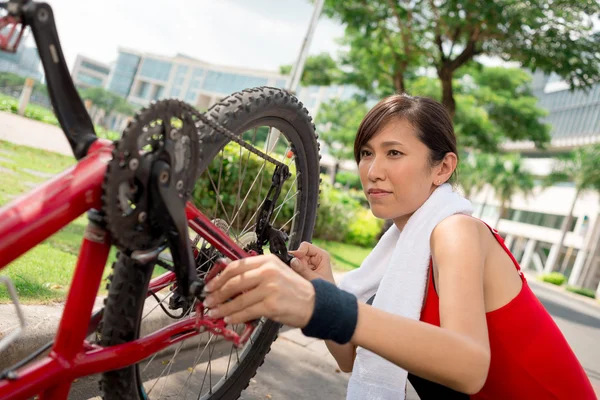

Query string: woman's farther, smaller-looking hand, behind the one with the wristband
289 242 335 284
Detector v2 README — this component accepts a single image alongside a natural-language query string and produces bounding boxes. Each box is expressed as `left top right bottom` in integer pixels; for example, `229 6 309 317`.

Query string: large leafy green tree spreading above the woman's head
324 0 600 116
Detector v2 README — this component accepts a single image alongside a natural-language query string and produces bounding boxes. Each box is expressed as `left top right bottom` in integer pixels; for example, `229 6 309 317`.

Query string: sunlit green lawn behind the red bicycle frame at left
0 141 115 303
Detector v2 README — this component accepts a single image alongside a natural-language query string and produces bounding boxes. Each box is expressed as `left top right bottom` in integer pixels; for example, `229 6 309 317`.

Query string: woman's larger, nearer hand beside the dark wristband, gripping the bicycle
204 254 315 328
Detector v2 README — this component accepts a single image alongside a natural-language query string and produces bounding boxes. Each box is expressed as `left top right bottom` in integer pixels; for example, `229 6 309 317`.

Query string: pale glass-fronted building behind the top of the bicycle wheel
100 48 358 172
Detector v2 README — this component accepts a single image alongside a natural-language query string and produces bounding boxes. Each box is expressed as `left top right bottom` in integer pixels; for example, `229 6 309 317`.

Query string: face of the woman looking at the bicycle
358 119 439 228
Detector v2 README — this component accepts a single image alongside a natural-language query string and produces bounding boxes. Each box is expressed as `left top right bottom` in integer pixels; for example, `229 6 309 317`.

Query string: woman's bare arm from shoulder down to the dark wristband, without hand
351 216 490 394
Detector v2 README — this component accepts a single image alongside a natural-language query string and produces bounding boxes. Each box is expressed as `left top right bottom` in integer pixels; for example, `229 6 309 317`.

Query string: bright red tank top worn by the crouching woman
421 220 597 400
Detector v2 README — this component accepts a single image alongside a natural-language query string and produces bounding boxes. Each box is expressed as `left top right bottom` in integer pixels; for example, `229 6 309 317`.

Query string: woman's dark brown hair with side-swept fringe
354 94 458 180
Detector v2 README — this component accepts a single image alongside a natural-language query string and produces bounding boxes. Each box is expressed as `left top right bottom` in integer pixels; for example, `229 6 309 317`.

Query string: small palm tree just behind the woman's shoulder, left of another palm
491 154 534 228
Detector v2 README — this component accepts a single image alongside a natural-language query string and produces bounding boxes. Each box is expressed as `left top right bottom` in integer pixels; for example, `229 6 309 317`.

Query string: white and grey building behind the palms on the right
474 73 600 297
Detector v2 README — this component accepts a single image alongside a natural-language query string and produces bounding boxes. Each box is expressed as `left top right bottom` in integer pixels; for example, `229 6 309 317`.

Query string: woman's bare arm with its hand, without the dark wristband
207 216 490 394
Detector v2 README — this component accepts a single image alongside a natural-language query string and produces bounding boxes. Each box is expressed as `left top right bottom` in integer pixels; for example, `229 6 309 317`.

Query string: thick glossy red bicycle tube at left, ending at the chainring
0 142 111 269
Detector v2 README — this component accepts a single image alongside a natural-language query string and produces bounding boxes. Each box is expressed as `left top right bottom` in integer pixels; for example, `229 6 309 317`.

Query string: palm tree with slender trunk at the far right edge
544 144 600 272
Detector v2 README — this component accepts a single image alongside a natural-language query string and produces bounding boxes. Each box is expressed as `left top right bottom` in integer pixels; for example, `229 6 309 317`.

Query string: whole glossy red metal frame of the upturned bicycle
0 140 255 400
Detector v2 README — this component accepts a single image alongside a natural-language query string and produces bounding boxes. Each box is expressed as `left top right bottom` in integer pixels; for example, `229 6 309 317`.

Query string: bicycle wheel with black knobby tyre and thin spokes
100 87 320 400
